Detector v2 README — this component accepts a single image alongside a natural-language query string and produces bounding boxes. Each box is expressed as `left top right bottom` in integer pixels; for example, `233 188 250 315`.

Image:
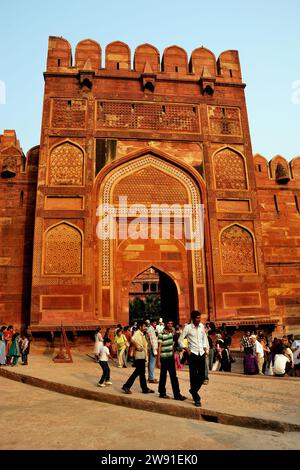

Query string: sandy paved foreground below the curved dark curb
0 376 300 450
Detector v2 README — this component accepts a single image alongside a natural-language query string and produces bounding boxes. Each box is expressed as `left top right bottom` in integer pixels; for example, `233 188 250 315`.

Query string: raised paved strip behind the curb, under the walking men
1 351 300 425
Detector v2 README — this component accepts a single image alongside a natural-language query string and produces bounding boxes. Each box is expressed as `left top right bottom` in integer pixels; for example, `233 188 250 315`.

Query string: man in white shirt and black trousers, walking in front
179 310 209 407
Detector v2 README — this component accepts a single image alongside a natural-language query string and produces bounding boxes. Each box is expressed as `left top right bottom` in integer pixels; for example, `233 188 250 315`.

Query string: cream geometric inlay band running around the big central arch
99 155 203 286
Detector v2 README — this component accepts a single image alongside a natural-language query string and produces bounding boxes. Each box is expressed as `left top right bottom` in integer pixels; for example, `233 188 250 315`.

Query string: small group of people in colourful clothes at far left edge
0 325 30 367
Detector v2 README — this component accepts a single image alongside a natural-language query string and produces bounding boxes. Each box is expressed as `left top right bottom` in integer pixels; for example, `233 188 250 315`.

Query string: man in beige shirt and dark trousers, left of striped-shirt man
122 321 154 393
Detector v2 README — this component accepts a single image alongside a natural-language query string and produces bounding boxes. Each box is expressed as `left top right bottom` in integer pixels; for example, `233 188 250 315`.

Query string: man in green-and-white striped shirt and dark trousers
157 321 186 401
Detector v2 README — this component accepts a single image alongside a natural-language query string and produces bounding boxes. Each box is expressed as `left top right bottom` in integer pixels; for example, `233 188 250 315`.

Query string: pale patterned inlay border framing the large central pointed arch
98 154 203 287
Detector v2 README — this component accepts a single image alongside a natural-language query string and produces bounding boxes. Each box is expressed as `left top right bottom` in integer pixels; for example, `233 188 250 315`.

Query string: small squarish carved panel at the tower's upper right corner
208 106 242 136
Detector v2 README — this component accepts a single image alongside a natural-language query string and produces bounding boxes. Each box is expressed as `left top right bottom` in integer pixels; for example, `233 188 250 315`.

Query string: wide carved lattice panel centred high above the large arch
96 101 200 132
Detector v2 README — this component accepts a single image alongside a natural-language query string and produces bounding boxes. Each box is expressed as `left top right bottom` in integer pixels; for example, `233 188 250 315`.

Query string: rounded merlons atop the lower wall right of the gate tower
254 154 300 185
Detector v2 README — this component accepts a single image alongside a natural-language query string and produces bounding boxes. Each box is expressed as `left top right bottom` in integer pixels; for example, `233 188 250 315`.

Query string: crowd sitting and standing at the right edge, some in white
240 331 300 377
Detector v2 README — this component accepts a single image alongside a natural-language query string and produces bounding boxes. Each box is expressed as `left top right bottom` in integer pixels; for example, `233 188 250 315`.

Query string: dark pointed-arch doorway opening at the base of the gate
129 266 179 325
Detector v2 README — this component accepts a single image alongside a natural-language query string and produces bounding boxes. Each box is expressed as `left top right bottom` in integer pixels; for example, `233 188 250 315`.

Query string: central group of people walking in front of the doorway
95 311 209 407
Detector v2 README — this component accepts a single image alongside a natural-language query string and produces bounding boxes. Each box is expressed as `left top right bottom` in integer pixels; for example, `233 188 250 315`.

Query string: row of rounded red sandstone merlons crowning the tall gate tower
47 36 242 83
